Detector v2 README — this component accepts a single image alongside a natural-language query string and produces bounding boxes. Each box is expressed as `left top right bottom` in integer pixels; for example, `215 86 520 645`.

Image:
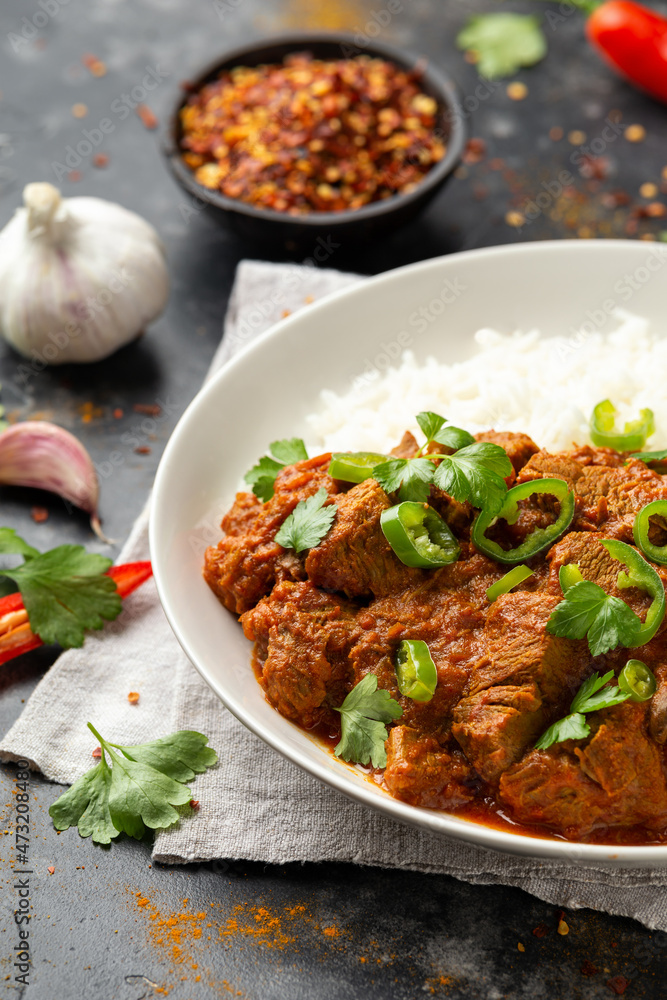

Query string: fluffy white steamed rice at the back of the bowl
307 310 667 453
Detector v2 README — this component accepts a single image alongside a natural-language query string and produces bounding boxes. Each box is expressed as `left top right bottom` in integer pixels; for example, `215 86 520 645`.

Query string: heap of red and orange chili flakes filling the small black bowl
181 53 446 215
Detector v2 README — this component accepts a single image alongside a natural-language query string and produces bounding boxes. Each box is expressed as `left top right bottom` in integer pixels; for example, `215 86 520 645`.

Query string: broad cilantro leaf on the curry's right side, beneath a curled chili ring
547 580 642 656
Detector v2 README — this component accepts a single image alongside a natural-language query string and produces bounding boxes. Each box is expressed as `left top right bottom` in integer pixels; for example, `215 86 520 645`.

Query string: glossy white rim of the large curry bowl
149 239 667 869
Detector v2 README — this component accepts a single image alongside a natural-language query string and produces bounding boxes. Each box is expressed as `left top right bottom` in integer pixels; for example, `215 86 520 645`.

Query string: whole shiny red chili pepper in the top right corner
586 0 667 103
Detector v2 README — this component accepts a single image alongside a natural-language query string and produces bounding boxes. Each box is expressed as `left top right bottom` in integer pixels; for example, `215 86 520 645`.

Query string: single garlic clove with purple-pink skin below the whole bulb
0 420 110 542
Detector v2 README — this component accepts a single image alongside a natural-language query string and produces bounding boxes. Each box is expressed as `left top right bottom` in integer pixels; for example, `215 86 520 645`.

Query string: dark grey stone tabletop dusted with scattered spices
0 0 667 1000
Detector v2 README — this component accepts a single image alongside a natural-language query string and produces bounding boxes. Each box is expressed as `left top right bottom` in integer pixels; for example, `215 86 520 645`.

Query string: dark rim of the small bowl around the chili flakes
160 31 467 228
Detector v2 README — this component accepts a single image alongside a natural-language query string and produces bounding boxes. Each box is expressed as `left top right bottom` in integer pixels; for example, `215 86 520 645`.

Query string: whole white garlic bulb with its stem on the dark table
0 184 169 367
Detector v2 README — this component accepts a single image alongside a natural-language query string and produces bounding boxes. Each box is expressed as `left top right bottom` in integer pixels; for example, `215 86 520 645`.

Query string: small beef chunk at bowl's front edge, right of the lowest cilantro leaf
384 726 475 809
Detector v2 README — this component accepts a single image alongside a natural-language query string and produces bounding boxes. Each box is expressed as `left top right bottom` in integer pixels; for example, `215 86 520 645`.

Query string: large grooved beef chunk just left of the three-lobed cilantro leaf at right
452 592 590 783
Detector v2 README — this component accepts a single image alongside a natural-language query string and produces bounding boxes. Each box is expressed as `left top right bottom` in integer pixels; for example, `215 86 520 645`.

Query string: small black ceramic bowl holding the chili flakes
163 32 466 249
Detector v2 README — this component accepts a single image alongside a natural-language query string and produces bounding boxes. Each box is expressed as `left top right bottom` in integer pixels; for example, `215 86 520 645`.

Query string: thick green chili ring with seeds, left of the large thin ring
380 500 461 569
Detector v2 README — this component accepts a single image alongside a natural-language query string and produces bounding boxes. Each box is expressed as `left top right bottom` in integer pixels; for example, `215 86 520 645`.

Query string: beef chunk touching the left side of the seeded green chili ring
306 479 424 597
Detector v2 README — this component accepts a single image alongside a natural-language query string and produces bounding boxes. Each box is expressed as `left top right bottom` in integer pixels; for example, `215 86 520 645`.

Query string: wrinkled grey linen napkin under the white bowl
0 261 667 930
